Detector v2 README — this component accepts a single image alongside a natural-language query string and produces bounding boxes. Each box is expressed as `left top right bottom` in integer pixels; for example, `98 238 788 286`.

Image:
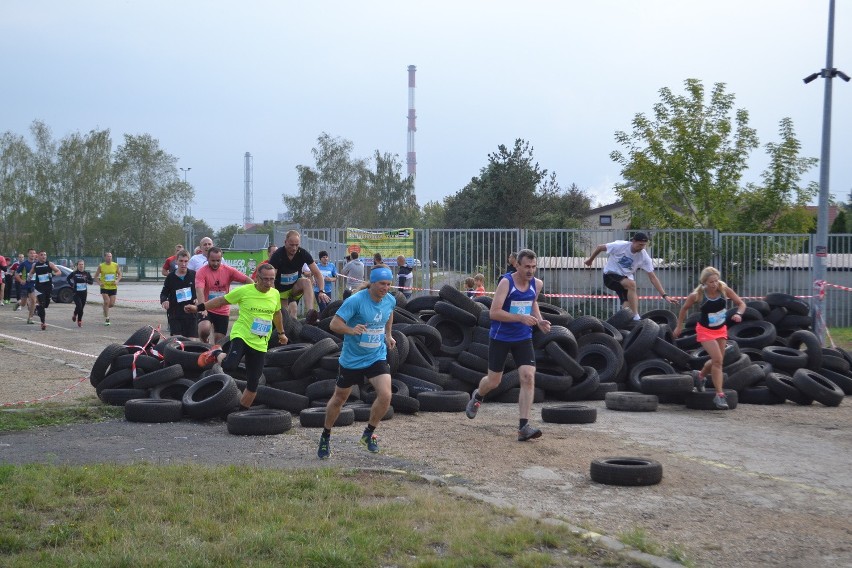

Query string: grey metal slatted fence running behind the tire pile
87 228 852 327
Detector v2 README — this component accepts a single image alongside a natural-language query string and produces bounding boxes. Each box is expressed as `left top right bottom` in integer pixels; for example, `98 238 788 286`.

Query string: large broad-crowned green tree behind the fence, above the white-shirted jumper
610 79 758 231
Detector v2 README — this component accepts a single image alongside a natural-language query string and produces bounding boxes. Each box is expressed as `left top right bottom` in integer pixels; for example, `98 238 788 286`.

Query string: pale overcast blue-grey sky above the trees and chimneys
0 0 852 228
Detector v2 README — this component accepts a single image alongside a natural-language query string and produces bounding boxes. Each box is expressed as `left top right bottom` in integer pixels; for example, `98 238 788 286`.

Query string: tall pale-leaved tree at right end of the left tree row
111 134 190 256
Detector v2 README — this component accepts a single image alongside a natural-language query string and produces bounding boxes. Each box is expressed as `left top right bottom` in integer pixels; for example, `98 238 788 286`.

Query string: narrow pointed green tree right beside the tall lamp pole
732 118 819 233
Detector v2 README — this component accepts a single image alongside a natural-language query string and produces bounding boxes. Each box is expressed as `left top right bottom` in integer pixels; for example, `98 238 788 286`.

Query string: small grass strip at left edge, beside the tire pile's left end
0 397 124 432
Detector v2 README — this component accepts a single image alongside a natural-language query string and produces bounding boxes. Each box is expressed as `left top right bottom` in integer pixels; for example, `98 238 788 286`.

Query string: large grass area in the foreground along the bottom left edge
0 464 639 567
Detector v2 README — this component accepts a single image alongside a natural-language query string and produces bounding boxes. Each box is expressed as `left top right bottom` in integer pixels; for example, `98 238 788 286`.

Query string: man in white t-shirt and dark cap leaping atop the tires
586 232 677 320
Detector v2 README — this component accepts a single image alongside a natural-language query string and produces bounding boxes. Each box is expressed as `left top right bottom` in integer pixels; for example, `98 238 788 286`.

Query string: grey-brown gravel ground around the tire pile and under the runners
0 285 852 567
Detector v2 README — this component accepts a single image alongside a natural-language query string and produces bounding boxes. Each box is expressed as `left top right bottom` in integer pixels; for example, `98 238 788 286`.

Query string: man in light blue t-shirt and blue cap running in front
317 266 396 459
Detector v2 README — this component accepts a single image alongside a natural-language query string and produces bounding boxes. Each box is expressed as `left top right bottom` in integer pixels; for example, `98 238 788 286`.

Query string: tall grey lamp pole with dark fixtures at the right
804 0 849 345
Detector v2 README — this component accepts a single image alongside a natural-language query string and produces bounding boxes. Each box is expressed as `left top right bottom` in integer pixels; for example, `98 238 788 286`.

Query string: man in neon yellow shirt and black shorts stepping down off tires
183 263 288 408
